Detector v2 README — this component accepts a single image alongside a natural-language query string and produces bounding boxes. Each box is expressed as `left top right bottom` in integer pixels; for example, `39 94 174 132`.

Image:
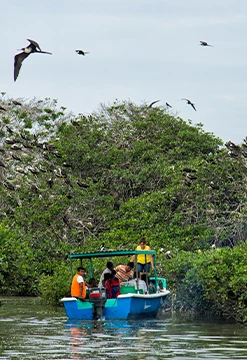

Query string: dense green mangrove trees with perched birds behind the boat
0 93 247 322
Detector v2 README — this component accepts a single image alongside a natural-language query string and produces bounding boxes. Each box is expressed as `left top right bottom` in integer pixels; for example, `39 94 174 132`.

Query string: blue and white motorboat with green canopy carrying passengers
61 250 170 320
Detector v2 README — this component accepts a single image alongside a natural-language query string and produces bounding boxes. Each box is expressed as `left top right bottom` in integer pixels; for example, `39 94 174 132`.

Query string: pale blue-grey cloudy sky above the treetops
0 0 247 144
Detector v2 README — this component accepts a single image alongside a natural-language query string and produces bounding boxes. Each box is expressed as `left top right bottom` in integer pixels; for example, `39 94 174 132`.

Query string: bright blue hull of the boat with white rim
61 290 170 320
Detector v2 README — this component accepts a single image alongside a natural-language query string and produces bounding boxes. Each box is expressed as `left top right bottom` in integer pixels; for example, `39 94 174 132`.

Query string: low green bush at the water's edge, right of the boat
165 244 247 323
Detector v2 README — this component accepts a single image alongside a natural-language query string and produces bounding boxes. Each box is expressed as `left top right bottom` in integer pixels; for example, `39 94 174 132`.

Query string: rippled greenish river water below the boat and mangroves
0 297 247 360
